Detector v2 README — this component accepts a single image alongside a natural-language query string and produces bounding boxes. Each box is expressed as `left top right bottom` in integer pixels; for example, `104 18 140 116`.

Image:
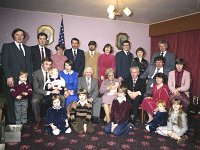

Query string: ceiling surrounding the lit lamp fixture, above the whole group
0 0 200 24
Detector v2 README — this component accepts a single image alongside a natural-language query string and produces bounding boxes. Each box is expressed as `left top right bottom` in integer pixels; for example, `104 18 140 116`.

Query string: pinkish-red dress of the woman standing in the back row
98 53 116 85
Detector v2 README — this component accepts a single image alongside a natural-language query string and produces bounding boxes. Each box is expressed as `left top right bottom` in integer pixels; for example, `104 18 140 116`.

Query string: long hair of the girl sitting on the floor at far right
169 98 183 128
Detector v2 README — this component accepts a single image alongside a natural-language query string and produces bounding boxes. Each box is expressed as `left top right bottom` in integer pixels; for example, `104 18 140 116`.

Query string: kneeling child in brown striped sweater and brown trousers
70 89 95 134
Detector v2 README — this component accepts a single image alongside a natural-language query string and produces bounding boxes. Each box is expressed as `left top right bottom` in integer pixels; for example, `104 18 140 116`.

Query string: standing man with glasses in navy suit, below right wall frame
115 40 133 82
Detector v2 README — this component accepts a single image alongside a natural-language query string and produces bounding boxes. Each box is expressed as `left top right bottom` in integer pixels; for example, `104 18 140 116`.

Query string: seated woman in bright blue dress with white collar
60 60 78 115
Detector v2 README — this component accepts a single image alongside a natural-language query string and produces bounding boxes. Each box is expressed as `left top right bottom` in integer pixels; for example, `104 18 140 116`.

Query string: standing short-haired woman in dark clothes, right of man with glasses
131 47 149 74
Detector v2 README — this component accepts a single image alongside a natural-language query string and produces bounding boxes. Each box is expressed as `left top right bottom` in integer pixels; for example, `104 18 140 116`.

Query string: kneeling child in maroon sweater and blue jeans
105 87 133 136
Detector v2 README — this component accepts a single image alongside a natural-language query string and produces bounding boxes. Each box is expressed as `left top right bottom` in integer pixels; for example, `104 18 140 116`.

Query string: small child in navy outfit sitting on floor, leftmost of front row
46 95 71 135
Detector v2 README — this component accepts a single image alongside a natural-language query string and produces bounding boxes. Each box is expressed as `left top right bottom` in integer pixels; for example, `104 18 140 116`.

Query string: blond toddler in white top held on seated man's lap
45 68 65 95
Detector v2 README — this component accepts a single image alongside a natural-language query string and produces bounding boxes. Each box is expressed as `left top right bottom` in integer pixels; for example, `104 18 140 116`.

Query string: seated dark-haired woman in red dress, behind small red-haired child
141 73 169 122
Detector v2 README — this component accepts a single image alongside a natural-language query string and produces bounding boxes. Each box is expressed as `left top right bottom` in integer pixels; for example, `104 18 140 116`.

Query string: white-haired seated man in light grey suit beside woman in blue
78 67 102 123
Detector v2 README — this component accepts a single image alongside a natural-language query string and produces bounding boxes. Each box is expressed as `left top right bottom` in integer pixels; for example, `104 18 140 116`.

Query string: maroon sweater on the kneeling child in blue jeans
110 99 131 124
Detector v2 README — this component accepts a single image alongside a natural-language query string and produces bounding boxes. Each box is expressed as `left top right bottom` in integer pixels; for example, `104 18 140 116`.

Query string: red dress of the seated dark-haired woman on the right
141 84 169 114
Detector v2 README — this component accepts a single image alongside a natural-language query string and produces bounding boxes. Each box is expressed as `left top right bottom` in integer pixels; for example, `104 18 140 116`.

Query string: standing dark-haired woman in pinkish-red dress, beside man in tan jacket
98 44 115 86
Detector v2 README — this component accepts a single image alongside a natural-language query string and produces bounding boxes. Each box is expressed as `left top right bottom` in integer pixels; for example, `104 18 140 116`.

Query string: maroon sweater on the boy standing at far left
10 82 32 99
